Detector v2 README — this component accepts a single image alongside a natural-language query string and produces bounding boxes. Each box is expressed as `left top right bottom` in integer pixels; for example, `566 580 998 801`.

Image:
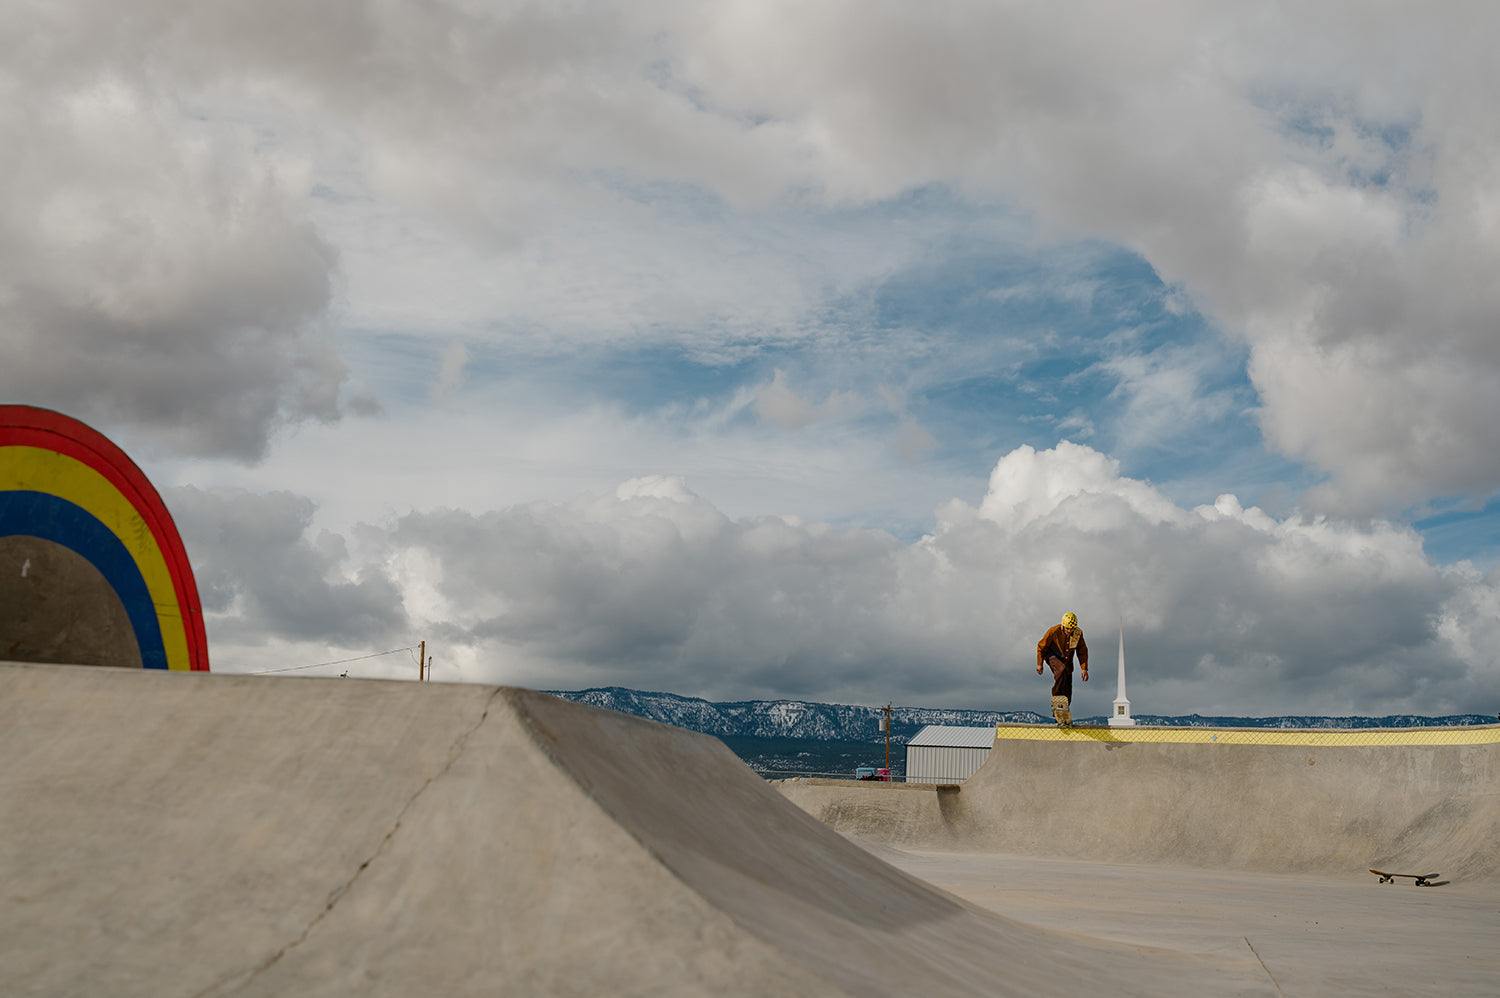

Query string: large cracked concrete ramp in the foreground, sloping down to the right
0 665 1269 998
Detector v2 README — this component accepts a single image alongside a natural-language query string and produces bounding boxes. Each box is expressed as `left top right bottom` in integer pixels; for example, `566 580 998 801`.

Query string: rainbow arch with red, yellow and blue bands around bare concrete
0 405 209 672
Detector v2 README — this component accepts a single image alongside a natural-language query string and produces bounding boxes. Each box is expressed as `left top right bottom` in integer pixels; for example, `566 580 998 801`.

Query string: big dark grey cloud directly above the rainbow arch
0 35 345 459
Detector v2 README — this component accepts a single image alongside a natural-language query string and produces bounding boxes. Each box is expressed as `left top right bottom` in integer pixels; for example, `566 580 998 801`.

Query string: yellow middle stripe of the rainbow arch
0 446 192 669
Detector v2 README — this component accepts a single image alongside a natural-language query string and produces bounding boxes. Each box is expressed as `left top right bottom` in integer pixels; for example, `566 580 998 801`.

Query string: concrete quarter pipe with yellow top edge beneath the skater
782 725 1500 881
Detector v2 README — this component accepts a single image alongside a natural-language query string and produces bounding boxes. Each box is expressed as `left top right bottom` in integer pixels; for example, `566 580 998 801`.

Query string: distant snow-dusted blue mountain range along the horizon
551 686 1496 744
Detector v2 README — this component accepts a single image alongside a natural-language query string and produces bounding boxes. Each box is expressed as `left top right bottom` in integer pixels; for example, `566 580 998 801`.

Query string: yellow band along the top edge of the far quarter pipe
995 725 1500 749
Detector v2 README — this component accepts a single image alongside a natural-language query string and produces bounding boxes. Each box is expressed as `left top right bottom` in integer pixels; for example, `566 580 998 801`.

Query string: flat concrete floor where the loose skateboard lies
878 846 1500 995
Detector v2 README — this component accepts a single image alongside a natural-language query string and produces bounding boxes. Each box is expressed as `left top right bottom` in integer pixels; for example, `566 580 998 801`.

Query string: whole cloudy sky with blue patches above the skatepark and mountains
0 0 1500 714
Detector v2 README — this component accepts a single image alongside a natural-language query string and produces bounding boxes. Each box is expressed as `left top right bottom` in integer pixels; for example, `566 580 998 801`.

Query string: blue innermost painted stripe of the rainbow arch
0 491 167 669
